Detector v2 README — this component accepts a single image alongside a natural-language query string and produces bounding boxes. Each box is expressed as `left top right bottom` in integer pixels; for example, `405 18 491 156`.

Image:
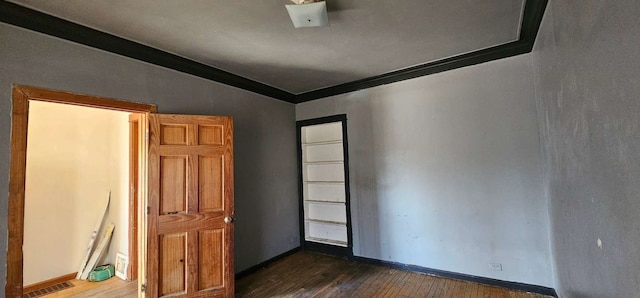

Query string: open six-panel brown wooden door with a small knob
145 114 234 297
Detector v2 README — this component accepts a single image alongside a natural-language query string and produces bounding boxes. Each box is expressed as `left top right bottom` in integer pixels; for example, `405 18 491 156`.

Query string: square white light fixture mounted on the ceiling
285 0 329 28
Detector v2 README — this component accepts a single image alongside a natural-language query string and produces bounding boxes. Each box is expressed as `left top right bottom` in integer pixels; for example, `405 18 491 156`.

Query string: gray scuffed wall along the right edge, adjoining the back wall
533 0 640 297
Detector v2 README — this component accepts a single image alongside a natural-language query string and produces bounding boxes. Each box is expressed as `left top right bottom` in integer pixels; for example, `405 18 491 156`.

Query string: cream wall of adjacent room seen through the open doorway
23 101 129 285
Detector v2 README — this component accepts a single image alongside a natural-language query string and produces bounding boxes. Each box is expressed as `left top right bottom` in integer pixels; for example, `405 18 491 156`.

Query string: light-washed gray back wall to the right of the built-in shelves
296 55 552 286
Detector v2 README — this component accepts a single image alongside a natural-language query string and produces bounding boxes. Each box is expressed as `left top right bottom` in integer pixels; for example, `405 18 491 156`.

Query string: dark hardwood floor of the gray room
236 252 547 298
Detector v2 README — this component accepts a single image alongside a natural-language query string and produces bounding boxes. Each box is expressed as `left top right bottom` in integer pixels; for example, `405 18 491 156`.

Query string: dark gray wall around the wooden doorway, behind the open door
0 24 299 288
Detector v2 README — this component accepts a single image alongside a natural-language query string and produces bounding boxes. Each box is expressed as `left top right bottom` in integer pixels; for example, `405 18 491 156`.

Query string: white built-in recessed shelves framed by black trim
299 119 351 249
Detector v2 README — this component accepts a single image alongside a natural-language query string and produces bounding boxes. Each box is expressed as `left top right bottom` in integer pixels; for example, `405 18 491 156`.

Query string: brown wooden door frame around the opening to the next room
5 86 156 297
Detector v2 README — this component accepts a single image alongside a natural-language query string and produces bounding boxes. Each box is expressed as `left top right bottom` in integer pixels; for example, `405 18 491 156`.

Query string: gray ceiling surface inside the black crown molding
10 0 525 95
